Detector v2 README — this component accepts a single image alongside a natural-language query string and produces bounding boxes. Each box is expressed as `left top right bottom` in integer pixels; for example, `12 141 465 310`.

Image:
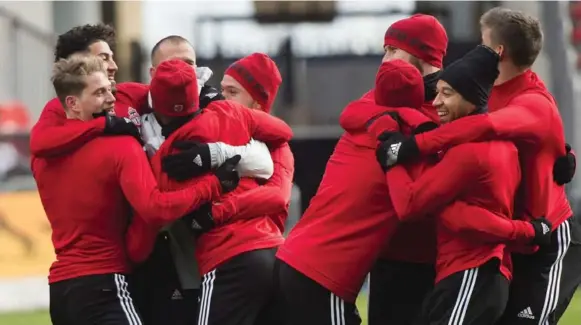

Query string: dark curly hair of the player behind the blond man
54 24 116 62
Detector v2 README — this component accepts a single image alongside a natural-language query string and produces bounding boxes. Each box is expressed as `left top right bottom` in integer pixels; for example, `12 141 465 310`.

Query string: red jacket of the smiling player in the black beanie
386 141 534 282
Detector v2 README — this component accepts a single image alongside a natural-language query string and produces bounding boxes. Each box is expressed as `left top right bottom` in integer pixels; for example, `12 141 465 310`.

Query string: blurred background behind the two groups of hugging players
0 0 581 325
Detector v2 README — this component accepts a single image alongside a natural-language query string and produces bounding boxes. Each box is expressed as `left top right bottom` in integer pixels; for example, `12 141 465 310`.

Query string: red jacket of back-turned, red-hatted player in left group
151 100 292 274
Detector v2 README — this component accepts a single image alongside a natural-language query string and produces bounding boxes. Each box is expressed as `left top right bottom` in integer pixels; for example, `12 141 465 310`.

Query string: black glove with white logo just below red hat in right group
375 132 420 171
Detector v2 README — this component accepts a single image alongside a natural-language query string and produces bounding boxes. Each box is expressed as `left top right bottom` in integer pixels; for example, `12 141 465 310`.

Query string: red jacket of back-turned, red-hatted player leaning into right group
277 101 436 302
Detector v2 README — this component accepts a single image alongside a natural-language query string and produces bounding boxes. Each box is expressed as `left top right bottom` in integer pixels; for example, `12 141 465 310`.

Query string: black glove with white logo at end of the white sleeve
161 141 212 181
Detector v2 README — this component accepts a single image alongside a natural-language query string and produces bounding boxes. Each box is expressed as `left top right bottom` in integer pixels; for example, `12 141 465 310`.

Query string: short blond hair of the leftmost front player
51 54 107 107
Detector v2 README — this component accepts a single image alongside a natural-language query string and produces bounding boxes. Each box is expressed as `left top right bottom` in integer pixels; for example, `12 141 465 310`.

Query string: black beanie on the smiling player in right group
440 45 500 110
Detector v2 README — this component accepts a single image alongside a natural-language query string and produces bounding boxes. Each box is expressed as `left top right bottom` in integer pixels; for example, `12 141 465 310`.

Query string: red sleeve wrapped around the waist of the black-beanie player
439 200 535 244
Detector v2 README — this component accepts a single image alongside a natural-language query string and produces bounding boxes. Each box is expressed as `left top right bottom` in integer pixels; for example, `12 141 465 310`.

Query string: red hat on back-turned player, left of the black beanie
375 60 424 109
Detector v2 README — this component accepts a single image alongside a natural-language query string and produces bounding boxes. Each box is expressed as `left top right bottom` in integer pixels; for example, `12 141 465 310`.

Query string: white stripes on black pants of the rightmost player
539 220 571 325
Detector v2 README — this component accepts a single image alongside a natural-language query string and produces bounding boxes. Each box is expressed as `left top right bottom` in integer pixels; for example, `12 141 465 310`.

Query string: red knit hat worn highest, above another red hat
383 14 448 68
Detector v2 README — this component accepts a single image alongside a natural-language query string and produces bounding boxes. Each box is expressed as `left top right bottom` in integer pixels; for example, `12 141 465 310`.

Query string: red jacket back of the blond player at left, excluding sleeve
32 137 138 282
